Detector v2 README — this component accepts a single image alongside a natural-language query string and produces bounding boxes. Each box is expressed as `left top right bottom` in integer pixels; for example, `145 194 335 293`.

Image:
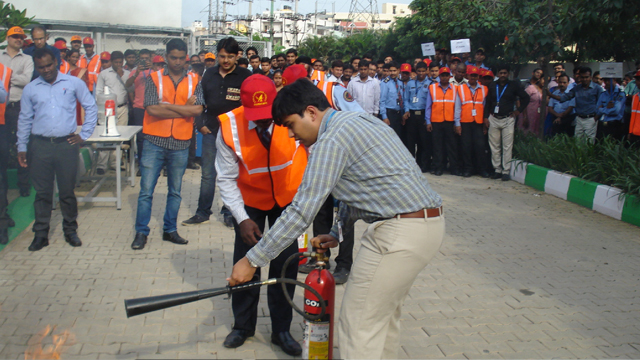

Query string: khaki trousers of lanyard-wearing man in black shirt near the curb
488 115 516 174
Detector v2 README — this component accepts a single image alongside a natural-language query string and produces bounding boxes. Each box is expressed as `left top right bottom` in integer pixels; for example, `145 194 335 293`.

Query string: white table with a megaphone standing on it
77 125 142 210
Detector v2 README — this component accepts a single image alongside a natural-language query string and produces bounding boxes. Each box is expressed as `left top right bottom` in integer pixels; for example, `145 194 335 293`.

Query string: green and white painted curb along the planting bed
511 160 640 226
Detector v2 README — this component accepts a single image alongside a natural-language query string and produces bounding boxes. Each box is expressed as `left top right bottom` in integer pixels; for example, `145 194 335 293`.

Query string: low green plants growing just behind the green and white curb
513 132 640 195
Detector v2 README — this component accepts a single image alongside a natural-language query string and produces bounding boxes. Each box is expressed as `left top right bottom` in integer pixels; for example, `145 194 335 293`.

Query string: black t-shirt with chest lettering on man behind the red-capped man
196 65 251 134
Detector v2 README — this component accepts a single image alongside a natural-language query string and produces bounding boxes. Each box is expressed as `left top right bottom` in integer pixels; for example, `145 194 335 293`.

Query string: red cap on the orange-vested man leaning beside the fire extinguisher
240 74 278 121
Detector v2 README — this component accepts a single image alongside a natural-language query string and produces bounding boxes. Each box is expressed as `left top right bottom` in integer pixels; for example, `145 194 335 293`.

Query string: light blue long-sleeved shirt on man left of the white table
17 72 98 152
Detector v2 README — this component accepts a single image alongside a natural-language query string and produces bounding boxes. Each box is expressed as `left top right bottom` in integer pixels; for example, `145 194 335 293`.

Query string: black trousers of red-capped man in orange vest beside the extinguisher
231 205 298 333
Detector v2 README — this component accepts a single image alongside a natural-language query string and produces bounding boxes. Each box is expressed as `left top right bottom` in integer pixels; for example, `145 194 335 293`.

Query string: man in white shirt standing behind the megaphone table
93 51 131 175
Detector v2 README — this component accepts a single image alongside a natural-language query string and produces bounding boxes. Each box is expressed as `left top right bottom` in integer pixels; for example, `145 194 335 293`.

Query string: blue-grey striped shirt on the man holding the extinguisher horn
247 110 442 267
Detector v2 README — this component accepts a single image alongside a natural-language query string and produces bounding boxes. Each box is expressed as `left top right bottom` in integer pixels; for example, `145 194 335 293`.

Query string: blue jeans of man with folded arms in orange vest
136 140 189 235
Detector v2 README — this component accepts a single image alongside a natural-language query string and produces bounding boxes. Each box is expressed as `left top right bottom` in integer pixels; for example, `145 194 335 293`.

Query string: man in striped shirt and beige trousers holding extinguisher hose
228 79 444 359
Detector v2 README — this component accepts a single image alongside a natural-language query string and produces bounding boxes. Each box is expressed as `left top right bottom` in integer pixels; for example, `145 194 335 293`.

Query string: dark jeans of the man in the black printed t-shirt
196 133 218 219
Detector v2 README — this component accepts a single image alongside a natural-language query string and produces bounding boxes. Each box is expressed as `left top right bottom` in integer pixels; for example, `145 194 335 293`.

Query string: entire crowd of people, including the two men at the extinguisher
0 26 640 357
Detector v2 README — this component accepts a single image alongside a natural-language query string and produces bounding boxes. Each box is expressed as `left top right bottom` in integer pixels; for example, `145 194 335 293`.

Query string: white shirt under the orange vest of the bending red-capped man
215 121 273 224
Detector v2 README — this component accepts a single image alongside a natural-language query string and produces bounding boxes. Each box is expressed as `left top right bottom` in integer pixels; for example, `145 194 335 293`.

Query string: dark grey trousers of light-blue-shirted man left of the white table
27 136 80 238
